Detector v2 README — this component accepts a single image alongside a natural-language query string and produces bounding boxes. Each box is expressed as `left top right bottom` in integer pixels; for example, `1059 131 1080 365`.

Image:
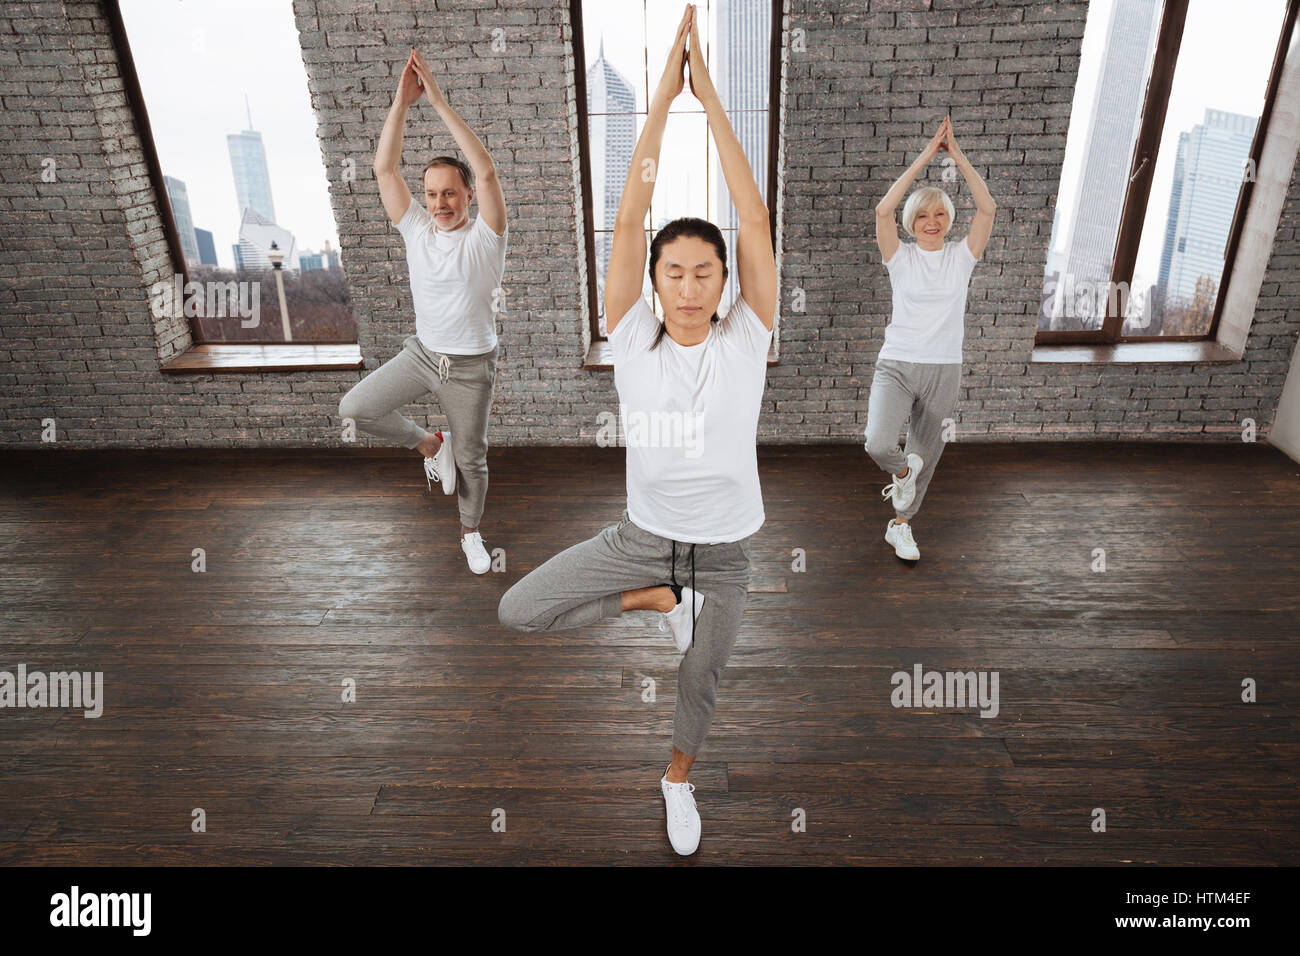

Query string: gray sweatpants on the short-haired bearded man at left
338 336 497 528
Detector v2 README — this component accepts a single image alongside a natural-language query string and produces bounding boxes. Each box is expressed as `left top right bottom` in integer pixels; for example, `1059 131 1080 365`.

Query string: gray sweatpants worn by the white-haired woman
866 359 962 520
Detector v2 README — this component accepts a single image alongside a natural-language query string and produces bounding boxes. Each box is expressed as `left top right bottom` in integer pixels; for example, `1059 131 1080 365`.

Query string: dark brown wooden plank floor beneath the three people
0 442 1300 865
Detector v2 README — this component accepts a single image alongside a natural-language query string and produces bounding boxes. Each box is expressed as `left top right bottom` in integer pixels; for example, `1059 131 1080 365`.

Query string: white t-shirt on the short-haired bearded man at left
398 196 510 355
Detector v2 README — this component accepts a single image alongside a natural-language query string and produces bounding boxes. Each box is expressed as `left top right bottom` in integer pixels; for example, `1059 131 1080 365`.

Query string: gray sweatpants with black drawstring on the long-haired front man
497 510 750 756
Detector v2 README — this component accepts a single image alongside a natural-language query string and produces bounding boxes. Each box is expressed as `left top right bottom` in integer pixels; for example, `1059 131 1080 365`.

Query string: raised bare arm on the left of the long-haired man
605 7 690 332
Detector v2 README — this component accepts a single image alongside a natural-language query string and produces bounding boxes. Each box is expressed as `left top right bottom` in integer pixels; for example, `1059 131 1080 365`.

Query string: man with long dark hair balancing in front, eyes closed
498 5 776 855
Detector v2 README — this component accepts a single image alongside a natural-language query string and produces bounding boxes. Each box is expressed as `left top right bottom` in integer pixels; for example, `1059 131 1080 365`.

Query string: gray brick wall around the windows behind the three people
0 0 1300 446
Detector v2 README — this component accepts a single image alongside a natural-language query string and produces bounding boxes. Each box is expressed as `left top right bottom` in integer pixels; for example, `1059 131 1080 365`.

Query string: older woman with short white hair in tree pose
866 116 997 561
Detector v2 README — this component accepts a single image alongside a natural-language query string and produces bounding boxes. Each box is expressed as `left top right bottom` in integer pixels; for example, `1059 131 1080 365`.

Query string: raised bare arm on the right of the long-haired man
688 5 776 329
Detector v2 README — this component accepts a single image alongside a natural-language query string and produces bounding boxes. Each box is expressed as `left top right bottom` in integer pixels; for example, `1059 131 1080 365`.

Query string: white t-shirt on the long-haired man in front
610 295 772 544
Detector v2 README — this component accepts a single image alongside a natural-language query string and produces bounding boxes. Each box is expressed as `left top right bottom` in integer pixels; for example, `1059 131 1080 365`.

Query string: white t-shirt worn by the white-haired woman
876 239 979 364
